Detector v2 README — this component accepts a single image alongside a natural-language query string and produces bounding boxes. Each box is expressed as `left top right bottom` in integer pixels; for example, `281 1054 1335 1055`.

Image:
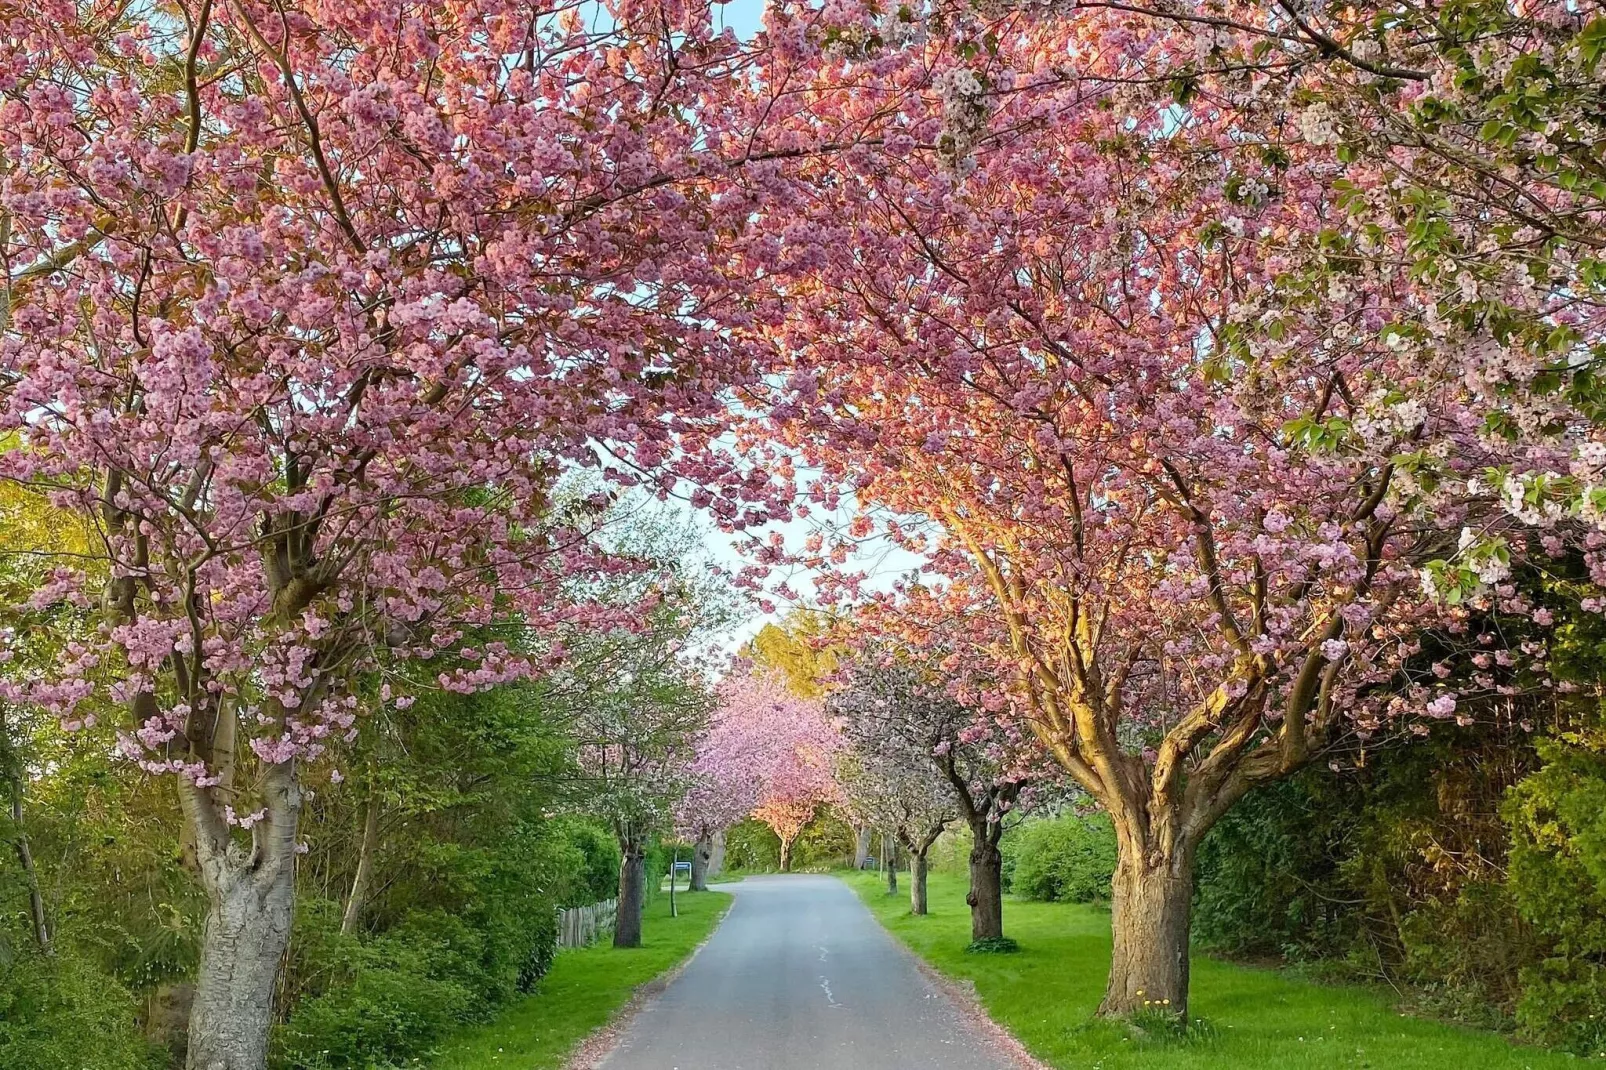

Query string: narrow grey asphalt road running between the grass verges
597 876 1018 1070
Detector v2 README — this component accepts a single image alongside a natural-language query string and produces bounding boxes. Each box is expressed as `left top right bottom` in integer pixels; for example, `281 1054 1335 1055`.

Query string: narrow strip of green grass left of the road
430 892 731 1070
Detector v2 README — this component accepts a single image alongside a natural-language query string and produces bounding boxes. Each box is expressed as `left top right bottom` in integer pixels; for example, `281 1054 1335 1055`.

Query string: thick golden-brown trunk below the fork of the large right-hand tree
1099 852 1193 1017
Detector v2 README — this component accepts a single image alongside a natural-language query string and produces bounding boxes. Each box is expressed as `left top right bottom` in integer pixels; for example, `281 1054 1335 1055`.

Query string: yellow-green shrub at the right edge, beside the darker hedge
1503 736 1606 1054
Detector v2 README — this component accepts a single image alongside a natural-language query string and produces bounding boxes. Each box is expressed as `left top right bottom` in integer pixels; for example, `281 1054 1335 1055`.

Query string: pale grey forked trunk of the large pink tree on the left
180 763 300 1070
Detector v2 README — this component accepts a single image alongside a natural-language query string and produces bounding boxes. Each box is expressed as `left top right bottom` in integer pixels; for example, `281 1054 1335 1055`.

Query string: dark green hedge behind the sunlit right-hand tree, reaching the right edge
1193 719 1606 1054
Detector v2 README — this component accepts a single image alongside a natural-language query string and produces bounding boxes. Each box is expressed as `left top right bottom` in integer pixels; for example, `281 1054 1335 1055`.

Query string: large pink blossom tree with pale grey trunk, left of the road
0 0 828 1070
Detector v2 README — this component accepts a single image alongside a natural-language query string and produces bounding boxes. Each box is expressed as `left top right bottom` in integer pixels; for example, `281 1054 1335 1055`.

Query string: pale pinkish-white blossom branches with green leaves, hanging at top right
906 0 1606 594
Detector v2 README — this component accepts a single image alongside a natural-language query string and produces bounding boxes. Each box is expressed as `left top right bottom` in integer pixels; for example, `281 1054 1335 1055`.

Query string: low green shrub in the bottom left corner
0 953 161 1070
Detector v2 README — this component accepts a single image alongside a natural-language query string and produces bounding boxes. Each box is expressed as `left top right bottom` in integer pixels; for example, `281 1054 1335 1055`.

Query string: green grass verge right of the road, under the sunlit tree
843 874 1580 1070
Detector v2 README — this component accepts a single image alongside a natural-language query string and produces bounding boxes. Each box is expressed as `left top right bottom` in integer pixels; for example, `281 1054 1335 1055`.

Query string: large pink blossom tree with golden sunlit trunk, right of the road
716 8 1503 1015
